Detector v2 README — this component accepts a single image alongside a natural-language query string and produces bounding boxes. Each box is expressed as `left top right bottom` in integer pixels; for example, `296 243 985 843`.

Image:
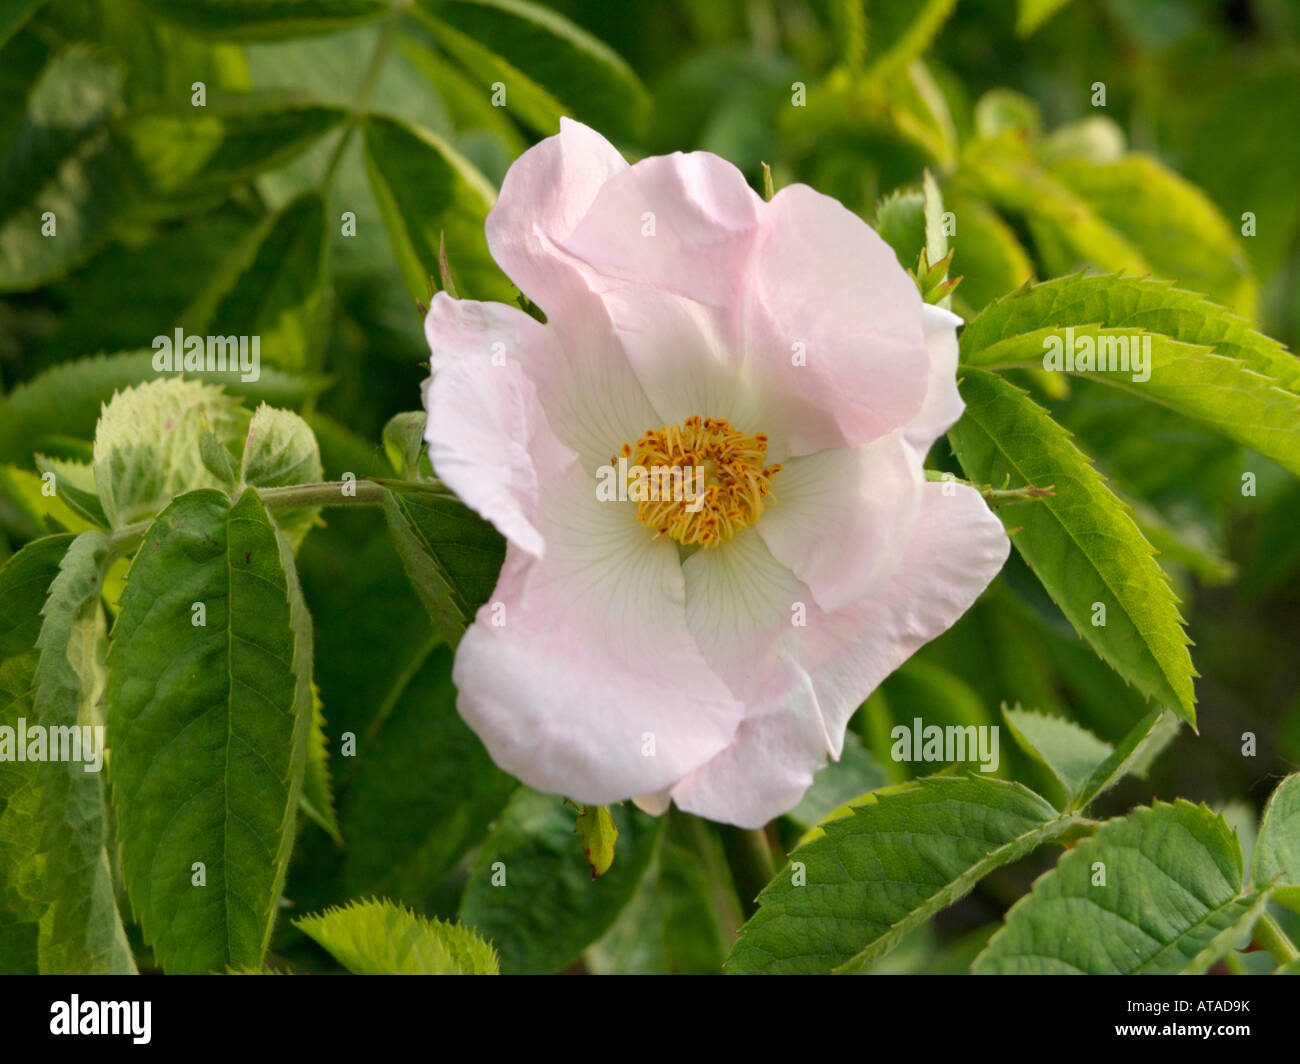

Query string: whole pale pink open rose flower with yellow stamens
425 120 1009 827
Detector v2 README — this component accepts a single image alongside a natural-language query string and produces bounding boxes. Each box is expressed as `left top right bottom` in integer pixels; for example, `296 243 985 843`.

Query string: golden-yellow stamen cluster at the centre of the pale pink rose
611 415 781 546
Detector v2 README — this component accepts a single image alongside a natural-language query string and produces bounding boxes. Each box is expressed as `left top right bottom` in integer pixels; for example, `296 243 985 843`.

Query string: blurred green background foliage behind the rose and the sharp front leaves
0 0 1300 970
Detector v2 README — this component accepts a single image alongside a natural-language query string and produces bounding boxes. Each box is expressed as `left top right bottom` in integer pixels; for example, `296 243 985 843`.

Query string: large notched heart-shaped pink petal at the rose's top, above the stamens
564 170 930 460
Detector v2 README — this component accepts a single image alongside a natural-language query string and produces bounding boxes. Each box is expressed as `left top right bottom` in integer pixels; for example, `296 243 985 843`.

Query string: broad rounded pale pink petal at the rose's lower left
452 466 744 805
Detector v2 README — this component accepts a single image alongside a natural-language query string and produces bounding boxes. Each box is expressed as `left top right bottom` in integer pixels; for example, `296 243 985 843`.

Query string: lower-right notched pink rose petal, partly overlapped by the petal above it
672 484 1010 827
